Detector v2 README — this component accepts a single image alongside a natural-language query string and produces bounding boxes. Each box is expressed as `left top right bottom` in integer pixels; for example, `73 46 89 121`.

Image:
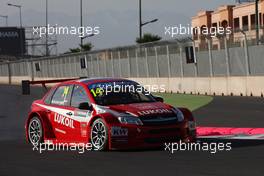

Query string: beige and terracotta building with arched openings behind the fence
192 0 264 50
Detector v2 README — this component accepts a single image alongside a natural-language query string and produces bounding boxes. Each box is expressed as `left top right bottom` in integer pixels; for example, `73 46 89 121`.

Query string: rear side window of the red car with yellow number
51 86 72 106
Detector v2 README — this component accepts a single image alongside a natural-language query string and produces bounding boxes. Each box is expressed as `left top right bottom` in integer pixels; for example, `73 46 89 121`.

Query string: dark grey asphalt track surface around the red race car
0 85 264 176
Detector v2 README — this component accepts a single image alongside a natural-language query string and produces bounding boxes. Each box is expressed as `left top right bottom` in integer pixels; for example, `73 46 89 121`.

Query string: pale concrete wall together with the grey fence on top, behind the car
0 43 264 96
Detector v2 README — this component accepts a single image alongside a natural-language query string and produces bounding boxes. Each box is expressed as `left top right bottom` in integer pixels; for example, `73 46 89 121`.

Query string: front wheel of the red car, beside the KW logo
91 119 108 151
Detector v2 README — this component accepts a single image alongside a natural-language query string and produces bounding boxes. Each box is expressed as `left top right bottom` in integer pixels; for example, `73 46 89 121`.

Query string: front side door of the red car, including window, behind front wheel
70 84 92 142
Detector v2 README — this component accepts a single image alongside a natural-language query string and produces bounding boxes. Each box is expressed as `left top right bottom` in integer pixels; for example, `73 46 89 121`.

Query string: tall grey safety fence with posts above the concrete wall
0 38 264 79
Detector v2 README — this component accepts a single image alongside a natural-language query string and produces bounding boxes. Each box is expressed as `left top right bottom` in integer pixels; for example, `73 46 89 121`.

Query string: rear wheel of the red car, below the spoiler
28 117 43 145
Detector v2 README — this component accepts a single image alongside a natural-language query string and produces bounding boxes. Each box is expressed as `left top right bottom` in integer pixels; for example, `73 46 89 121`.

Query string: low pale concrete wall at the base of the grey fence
0 76 264 97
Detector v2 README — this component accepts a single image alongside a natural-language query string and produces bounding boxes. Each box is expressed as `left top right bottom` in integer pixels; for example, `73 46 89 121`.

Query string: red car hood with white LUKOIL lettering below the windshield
94 102 175 116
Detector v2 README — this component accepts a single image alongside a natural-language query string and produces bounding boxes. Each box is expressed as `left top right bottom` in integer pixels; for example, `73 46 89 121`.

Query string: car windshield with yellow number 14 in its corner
88 81 155 106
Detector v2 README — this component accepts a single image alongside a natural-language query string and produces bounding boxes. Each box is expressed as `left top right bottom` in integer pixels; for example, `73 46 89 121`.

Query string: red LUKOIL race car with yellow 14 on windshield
25 78 196 150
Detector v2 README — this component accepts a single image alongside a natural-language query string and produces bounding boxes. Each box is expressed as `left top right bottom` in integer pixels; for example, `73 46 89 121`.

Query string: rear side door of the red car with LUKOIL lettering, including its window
48 85 77 142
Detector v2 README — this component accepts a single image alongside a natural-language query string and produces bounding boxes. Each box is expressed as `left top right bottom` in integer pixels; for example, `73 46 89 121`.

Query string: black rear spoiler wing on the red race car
21 77 87 95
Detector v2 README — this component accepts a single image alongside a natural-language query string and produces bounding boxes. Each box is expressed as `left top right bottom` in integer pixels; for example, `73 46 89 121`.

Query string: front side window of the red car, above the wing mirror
71 85 90 108
